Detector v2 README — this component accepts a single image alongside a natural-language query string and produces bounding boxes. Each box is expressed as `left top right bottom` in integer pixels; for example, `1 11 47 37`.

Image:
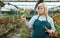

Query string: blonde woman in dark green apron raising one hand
21 3 55 38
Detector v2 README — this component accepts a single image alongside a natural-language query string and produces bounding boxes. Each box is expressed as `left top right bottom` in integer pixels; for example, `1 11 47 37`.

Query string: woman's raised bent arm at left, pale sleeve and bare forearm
21 15 36 28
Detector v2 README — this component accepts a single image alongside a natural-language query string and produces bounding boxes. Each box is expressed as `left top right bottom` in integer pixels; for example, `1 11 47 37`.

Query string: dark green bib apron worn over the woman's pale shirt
32 16 52 38
